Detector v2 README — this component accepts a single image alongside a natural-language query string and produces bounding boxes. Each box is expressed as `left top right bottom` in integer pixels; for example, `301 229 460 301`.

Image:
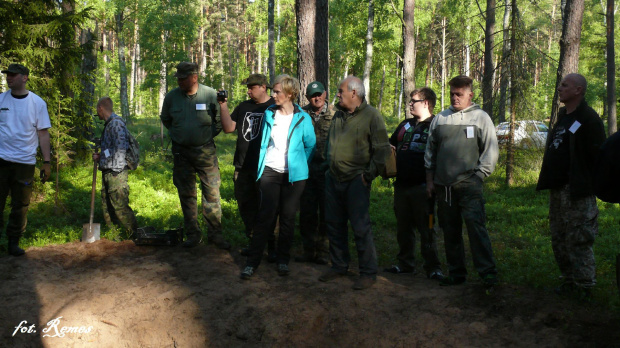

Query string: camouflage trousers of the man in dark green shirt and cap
172 142 222 239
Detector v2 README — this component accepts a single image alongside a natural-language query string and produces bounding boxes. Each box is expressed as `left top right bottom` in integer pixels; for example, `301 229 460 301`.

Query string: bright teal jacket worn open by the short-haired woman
256 104 316 182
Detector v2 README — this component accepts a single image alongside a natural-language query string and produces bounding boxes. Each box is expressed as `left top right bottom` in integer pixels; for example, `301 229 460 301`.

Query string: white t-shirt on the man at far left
0 90 52 164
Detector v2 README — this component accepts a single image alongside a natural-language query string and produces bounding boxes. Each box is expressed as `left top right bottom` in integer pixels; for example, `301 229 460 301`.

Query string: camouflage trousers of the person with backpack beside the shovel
101 170 138 233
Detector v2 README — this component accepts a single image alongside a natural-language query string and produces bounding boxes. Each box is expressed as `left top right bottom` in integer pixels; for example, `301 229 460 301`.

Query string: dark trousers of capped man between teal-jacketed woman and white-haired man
299 164 329 255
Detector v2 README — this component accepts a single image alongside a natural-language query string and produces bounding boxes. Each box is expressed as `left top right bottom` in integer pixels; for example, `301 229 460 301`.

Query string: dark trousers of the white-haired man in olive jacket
325 172 377 278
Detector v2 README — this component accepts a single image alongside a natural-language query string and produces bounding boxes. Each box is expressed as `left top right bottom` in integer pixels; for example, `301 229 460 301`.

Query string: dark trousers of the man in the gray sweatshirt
435 175 497 277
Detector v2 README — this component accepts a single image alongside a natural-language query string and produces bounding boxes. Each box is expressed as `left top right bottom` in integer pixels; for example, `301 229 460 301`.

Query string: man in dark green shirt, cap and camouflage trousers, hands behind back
160 62 230 249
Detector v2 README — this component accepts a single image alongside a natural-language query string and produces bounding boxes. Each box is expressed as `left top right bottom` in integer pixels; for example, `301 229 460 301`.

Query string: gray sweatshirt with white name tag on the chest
424 104 499 186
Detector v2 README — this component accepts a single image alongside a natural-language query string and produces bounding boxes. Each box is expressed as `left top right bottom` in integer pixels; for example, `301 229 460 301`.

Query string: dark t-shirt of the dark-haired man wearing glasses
390 117 432 186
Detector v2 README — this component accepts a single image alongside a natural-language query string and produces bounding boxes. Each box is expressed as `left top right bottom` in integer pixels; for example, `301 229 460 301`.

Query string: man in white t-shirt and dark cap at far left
0 64 51 256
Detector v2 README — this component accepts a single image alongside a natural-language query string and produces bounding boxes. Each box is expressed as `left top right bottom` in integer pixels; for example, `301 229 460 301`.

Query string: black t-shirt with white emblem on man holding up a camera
230 98 275 172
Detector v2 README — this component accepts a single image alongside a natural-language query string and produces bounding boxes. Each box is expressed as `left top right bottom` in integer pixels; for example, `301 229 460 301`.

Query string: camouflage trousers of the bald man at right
549 185 598 287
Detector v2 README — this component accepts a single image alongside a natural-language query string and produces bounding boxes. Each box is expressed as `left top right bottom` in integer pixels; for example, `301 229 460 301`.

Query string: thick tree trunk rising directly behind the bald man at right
549 0 584 128
